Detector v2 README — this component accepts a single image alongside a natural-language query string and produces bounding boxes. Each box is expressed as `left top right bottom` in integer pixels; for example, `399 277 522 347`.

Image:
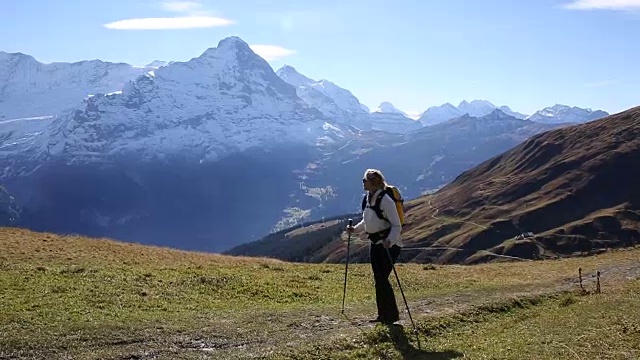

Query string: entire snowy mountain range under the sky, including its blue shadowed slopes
0 37 603 251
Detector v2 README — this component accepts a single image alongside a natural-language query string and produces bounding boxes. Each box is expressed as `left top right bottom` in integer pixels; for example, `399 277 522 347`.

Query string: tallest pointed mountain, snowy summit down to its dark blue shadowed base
0 37 349 250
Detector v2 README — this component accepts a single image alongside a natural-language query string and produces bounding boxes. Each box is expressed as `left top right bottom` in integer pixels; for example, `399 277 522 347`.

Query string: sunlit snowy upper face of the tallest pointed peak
5 37 332 167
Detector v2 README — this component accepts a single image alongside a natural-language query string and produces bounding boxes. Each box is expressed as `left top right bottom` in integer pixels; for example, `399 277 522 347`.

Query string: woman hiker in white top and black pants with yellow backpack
347 169 402 324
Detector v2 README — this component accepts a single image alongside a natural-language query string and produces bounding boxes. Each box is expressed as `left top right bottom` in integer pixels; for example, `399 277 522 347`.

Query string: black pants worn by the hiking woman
370 244 400 322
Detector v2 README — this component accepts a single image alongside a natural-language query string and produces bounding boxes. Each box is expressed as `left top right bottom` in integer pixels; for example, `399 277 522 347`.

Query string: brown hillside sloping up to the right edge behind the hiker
396 107 640 263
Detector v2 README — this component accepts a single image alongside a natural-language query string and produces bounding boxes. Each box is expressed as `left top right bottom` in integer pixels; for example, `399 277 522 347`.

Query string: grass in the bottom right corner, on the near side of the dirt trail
274 280 640 359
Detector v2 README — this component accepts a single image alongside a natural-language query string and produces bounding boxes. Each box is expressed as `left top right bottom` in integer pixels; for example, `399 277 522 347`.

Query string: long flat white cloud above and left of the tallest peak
104 16 233 30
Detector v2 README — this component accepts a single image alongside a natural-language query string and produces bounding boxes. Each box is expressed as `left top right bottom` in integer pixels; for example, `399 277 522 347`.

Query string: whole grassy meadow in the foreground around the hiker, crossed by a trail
0 229 640 359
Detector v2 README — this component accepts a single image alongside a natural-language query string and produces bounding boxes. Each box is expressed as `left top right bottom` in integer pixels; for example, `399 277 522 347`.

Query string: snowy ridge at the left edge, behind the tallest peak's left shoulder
0 52 150 120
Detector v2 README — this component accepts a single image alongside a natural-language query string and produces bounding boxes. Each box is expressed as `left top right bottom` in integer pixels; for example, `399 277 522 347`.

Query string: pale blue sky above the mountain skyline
0 0 640 114
